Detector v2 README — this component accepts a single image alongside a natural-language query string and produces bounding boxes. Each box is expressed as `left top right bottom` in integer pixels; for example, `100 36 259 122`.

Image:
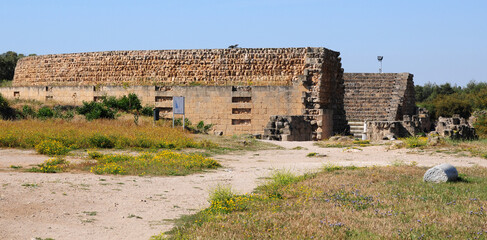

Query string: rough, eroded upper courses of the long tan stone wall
13 48 336 86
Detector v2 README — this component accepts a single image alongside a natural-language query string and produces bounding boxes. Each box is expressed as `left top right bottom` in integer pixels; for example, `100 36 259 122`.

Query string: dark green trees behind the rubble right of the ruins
415 81 487 119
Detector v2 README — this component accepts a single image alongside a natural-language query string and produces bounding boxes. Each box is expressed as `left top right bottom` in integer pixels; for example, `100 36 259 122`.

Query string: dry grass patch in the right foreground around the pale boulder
165 166 487 239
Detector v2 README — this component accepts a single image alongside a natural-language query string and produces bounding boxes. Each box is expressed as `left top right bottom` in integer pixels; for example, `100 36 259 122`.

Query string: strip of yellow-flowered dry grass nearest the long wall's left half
0 119 198 149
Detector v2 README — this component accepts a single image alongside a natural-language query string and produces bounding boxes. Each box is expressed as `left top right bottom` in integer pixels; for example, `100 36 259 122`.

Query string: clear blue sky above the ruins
0 0 487 86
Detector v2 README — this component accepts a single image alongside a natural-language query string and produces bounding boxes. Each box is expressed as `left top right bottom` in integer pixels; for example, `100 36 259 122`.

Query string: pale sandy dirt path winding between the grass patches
0 142 487 240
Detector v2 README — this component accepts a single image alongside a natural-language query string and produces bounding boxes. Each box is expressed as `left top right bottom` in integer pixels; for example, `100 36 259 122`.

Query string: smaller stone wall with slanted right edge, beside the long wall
343 73 416 121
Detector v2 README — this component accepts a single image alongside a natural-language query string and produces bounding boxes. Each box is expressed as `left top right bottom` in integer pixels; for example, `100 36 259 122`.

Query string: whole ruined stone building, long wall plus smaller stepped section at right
0 47 420 140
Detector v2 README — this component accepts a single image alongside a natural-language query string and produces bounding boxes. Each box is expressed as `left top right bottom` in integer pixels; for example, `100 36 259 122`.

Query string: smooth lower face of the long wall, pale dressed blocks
0 86 304 135
